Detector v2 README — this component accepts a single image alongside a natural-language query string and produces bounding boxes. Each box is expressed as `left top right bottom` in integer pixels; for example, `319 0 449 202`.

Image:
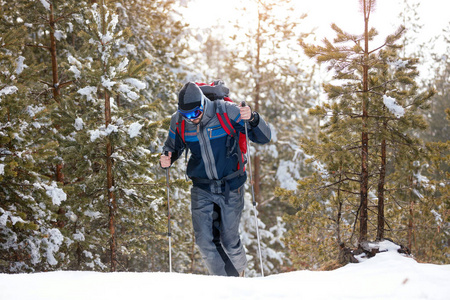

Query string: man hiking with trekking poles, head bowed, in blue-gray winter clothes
160 82 271 276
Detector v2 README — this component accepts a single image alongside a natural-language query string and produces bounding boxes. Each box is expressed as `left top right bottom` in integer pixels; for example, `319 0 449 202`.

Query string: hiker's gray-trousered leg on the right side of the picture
220 187 247 273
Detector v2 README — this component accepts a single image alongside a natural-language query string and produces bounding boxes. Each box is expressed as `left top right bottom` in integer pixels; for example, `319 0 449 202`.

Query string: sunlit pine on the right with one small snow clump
285 1 433 265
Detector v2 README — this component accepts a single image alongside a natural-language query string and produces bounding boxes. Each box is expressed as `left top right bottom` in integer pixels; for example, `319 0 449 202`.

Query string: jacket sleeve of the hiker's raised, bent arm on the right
225 102 272 144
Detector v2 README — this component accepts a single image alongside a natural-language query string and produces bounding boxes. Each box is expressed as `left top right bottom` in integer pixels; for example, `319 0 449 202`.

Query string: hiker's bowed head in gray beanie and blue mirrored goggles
178 82 206 124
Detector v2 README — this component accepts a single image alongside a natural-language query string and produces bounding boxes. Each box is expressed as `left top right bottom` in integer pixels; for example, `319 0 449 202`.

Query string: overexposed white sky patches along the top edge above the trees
184 0 450 47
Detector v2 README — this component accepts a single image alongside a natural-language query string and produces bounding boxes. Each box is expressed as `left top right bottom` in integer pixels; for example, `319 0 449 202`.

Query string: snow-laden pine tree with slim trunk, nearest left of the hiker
52 4 172 271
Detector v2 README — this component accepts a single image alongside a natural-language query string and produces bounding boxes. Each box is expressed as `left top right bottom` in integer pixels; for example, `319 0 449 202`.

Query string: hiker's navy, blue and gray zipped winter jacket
163 97 271 193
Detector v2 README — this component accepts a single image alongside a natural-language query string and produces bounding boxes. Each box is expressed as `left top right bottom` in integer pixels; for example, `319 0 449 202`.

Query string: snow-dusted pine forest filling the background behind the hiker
0 0 450 276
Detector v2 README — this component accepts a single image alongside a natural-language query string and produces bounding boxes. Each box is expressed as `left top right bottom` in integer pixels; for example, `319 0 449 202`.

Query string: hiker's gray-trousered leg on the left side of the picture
191 187 227 276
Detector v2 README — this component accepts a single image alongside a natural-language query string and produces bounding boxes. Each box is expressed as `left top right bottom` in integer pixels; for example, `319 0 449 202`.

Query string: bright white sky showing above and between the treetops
182 0 450 82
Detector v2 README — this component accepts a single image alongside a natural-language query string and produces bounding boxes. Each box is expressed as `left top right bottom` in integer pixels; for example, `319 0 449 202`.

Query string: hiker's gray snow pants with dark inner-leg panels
191 186 247 276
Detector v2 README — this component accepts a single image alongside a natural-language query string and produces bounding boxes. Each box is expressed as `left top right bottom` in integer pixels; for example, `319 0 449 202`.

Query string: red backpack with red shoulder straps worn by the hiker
177 80 247 172
